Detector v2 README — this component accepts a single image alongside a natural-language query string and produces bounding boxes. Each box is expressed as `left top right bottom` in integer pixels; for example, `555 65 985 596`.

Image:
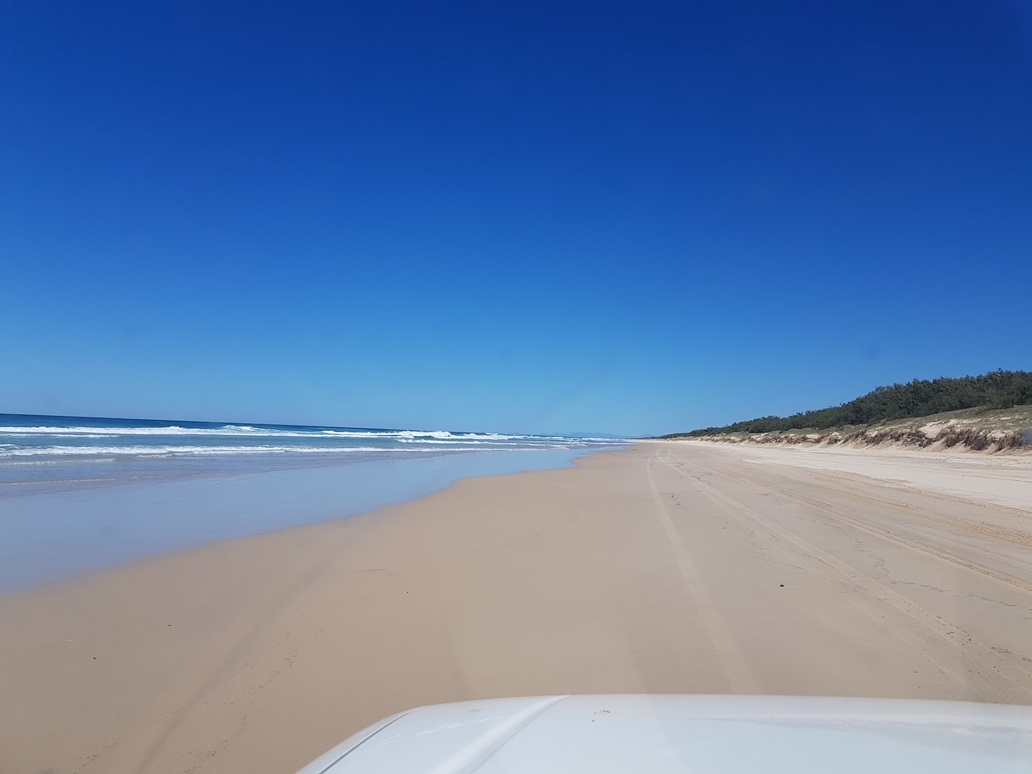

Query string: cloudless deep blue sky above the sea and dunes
0 0 1032 434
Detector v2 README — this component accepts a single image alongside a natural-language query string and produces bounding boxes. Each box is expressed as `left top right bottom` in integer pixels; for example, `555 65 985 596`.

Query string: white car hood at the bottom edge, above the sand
298 695 1032 774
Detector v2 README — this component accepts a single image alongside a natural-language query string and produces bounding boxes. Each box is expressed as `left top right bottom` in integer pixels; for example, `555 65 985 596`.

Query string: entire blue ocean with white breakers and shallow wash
0 414 621 593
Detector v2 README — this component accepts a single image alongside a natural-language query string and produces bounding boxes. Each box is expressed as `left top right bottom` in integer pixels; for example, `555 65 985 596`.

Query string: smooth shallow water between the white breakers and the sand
0 445 615 592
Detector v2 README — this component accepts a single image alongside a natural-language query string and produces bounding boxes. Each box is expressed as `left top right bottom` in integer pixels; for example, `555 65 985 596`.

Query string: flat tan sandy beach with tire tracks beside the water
0 442 1032 774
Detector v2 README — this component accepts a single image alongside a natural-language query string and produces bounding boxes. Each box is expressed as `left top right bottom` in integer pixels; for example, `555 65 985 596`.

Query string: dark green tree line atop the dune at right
663 370 1032 438
